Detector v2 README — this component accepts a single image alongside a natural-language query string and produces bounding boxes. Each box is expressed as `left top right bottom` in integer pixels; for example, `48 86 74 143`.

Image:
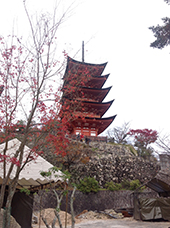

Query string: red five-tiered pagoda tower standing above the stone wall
62 57 116 136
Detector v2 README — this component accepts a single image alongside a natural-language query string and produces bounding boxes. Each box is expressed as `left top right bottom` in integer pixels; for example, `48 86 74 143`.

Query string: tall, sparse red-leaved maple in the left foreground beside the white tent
0 1 75 228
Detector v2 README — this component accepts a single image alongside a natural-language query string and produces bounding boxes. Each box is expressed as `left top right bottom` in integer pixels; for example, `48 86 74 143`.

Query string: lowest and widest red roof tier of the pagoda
72 115 117 135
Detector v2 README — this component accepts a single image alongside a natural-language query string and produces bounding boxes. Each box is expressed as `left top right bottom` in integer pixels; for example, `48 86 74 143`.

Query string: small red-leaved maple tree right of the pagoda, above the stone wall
128 129 158 158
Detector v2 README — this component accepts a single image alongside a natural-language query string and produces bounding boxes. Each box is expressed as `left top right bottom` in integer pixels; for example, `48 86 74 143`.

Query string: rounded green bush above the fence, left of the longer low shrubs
77 177 100 193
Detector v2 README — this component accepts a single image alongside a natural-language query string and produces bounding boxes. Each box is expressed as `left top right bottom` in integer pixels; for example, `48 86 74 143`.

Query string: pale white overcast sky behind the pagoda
0 0 170 133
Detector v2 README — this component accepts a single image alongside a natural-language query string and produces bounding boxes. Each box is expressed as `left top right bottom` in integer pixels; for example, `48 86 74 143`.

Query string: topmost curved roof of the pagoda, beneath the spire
63 57 107 79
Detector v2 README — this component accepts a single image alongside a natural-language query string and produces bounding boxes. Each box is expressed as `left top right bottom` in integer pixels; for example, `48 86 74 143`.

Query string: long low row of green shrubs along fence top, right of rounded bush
105 179 144 191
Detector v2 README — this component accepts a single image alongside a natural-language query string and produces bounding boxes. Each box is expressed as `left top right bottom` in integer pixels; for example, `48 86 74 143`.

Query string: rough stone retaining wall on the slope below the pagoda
70 143 160 187
